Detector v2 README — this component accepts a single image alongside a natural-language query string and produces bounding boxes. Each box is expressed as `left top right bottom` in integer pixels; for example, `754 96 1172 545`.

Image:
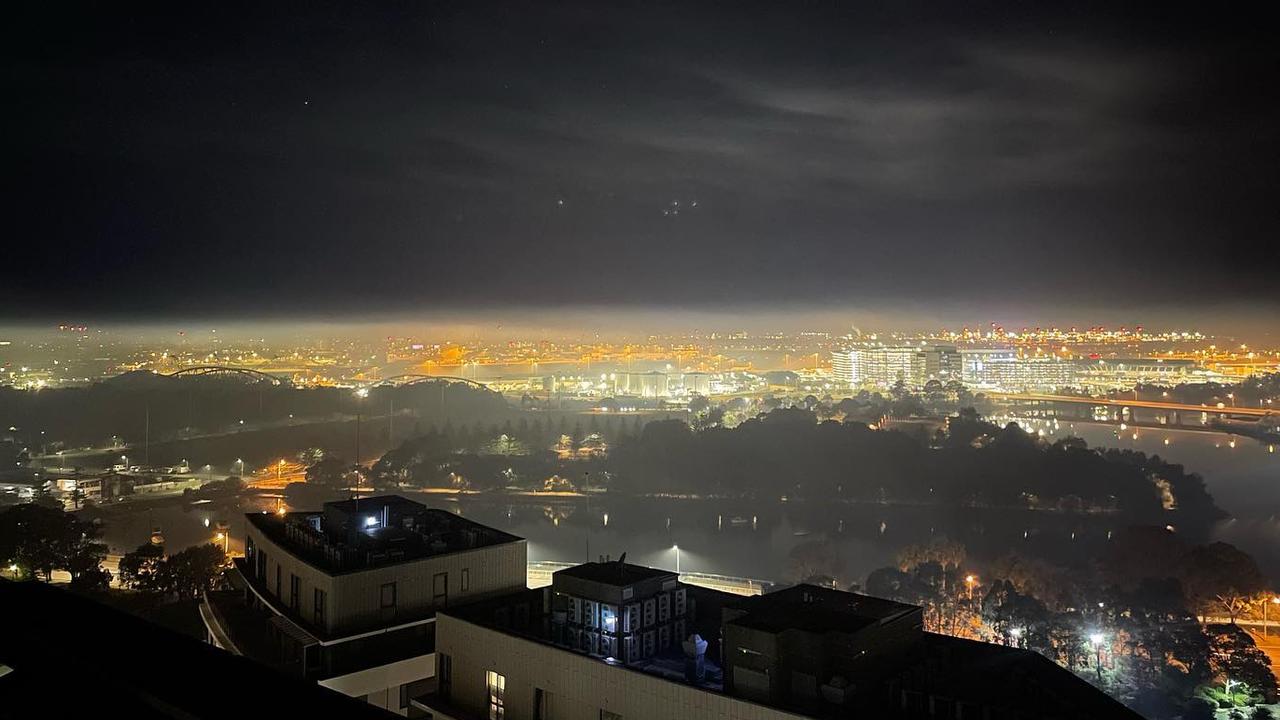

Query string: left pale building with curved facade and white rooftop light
201 496 526 715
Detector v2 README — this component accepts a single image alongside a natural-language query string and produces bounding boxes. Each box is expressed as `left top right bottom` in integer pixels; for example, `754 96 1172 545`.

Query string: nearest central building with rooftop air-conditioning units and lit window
411 562 1137 720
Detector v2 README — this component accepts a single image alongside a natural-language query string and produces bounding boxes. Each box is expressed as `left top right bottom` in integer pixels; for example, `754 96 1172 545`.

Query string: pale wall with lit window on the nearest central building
436 614 803 720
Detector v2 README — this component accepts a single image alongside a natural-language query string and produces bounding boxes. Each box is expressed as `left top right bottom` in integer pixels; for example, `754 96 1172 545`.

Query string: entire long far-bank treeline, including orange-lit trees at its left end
371 409 1222 534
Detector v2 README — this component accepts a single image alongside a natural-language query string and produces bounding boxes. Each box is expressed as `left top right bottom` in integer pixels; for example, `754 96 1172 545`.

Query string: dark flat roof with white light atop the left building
246 495 521 574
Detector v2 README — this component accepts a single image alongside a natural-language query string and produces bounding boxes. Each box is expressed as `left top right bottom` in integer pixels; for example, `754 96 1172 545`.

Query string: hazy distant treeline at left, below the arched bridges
0 373 511 452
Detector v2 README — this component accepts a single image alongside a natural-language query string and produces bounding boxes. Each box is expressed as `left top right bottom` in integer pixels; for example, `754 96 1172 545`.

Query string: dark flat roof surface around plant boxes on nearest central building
444 571 1138 720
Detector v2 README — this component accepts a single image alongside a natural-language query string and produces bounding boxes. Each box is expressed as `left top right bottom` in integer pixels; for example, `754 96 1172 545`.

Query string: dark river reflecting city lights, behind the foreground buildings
92 424 1280 584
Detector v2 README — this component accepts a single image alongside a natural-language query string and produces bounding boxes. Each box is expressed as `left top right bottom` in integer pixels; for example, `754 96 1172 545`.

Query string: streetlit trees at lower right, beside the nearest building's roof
860 527 1277 720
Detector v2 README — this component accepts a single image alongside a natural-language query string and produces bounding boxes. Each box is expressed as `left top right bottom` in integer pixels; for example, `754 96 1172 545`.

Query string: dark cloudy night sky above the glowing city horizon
0 1 1280 320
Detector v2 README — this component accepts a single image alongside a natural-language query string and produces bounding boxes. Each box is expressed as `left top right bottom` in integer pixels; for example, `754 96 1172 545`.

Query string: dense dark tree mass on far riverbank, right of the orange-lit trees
609 409 1221 530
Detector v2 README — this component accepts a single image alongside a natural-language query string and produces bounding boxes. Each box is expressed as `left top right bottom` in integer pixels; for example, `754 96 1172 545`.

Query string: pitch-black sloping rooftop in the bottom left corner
0 580 394 720
